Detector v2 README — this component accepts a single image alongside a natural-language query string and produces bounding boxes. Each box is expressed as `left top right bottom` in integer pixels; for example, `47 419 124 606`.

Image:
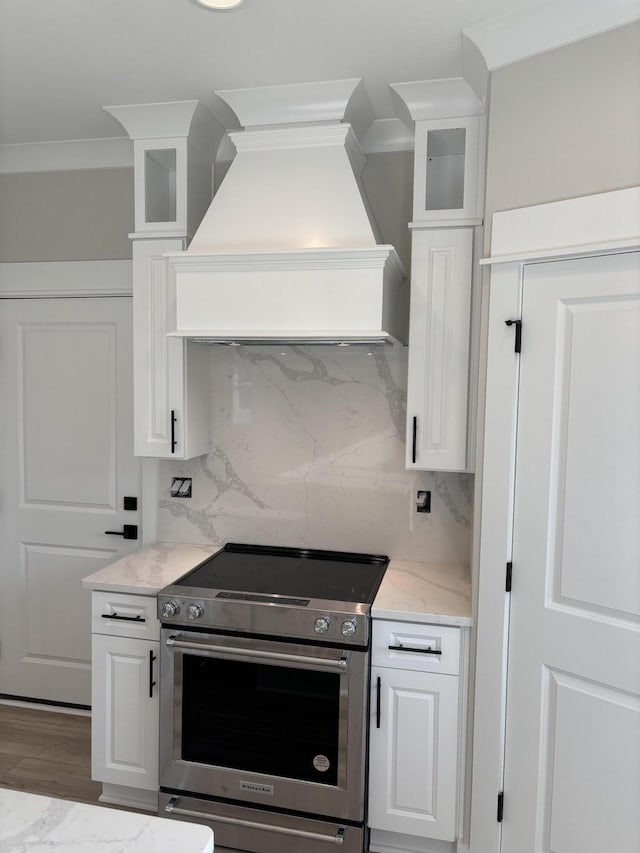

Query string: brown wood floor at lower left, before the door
0 704 102 804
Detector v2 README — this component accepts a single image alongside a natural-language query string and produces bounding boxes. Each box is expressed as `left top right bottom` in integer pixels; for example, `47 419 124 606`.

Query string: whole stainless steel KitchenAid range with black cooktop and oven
158 544 388 853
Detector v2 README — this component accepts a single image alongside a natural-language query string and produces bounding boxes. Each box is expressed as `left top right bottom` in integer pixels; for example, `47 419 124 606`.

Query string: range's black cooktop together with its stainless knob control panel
158 543 389 644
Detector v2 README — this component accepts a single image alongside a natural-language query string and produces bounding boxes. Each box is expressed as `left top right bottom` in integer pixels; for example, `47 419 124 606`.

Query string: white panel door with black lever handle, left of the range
0 297 141 705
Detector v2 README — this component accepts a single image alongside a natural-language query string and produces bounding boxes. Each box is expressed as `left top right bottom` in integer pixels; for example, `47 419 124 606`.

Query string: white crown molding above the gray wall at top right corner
462 0 640 71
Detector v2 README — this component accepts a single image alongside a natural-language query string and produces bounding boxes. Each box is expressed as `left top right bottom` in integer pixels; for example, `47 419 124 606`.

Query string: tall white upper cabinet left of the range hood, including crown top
105 101 224 459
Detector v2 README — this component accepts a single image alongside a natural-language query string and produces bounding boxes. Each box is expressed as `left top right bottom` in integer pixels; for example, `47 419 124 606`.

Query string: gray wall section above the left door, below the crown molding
0 169 133 262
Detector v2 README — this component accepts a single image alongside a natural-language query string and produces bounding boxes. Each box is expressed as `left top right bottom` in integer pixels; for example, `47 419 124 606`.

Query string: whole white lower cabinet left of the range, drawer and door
91 592 160 809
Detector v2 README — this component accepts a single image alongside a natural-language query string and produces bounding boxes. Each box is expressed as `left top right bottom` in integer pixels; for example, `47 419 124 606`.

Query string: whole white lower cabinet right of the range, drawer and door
368 620 460 851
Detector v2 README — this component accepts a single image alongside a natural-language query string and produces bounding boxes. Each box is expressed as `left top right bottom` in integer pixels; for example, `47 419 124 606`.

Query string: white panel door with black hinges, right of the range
502 253 640 853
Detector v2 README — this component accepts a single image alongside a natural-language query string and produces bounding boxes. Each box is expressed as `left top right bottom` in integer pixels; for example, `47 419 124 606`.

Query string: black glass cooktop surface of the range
174 543 389 604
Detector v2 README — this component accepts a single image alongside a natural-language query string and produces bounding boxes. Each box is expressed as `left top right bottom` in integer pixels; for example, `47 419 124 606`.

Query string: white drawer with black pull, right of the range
371 619 460 675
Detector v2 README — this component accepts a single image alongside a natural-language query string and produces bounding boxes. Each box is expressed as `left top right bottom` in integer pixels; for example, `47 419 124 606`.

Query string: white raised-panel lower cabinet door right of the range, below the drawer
369 667 458 841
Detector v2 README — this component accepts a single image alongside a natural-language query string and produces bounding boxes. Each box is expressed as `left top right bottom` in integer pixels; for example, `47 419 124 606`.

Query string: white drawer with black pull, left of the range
91 592 160 640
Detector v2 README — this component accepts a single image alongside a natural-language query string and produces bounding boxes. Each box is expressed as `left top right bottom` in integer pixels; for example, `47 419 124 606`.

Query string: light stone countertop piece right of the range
371 560 471 627
